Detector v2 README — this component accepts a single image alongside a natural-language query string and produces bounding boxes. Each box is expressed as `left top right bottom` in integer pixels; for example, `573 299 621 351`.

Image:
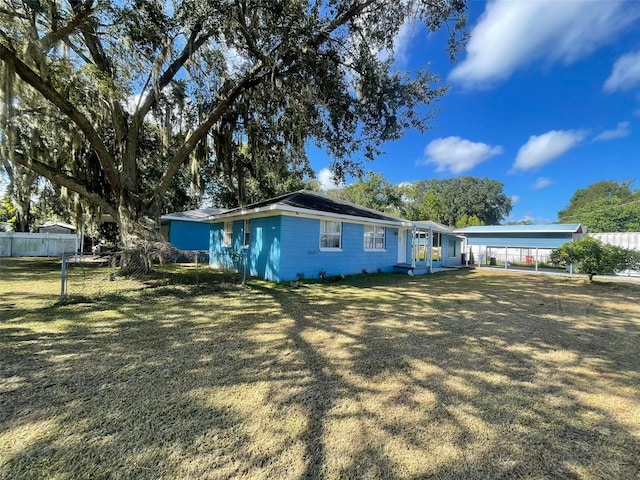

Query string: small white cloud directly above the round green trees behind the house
418 137 502 174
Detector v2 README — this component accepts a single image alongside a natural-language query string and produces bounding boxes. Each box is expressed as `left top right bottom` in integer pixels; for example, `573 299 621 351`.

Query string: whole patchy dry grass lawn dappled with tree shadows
0 259 640 479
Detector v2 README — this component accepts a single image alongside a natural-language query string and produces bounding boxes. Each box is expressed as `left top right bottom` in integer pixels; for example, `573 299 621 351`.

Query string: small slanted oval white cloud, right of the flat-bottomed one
513 130 585 170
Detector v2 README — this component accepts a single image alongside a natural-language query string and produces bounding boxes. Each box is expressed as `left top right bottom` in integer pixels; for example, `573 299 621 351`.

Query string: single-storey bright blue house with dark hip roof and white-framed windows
209 190 462 282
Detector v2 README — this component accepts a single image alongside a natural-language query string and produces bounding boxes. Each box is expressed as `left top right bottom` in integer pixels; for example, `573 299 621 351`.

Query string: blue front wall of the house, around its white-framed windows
280 216 398 280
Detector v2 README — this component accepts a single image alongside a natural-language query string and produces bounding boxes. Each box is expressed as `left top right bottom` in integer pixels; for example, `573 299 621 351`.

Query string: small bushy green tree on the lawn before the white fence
549 237 640 281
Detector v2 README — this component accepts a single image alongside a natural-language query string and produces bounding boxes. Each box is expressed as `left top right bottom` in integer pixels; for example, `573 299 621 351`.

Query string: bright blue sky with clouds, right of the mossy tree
309 0 640 223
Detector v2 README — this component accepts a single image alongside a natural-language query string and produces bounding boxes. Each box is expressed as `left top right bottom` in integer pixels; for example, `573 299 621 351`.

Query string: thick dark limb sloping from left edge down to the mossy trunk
0 44 121 193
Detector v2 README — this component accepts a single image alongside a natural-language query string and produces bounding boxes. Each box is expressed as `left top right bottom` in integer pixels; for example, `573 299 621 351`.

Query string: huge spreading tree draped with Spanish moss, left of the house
0 0 466 270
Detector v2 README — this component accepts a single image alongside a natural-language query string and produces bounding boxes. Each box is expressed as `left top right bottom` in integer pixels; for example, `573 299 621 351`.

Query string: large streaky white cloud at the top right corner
450 0 640 87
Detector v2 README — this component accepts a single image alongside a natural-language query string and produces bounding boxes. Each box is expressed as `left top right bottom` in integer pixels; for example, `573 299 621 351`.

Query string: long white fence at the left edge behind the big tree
0 232 80 257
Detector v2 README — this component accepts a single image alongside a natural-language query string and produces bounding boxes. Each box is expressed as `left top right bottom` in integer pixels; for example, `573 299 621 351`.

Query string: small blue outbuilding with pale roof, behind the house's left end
160 208 225 250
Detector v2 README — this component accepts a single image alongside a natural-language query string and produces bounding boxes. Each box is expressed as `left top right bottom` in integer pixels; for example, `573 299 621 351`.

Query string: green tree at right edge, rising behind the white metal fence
558 180 640 232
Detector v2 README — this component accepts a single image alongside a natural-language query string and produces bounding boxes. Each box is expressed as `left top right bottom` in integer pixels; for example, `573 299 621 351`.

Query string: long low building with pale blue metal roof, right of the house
454 223 587 268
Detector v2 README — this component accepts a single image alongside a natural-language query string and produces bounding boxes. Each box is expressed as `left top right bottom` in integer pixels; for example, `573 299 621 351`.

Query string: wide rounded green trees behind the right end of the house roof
403 176 512 225
